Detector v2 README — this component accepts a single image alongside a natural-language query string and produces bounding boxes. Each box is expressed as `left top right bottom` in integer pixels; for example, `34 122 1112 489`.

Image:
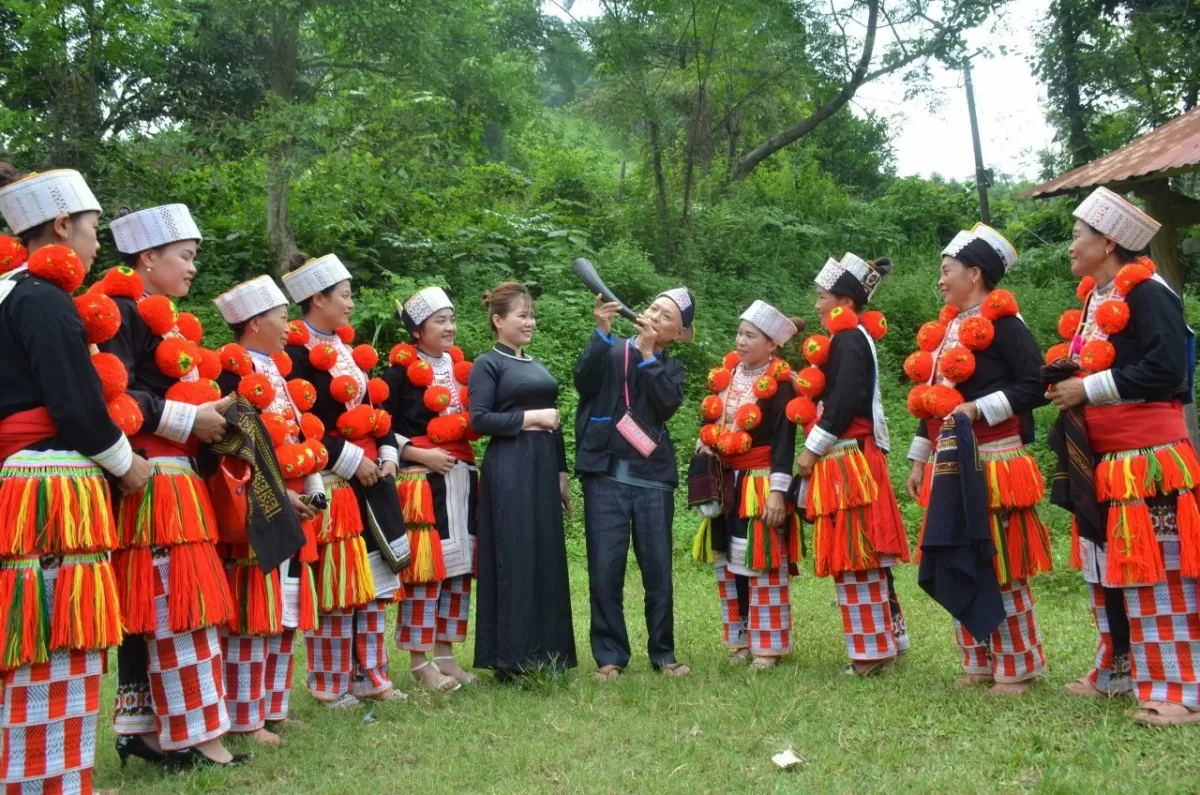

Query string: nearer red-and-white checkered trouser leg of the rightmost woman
1123 559 1200 711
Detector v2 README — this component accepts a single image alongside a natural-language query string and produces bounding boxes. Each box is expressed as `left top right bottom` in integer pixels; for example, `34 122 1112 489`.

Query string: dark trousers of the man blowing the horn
583 474 676 668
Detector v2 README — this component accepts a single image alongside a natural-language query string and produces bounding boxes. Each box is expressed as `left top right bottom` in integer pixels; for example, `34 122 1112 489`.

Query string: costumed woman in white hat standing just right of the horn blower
692 301 800 670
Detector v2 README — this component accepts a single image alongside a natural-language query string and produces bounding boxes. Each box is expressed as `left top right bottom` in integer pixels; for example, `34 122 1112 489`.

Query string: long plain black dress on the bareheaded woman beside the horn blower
469 345 576 674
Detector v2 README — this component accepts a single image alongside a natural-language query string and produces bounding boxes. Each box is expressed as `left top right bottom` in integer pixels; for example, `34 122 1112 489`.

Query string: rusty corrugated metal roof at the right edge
1026 108 1200 198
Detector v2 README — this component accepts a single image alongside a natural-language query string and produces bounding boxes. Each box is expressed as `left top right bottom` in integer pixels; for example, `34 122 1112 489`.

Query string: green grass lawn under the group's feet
96 516 1200 794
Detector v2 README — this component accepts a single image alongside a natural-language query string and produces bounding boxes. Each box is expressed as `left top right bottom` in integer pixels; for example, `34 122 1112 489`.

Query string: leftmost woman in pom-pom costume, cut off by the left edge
0 163 150 794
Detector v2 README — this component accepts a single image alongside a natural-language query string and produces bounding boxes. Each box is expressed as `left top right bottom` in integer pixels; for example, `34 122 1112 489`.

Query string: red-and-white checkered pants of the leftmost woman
0 651 103 794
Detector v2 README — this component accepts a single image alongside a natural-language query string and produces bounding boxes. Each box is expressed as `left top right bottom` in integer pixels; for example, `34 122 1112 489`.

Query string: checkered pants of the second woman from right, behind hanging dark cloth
954 580 1046 683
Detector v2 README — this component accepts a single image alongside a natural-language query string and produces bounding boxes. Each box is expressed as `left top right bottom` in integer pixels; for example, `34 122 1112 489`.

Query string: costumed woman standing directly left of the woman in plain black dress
384 287 479 691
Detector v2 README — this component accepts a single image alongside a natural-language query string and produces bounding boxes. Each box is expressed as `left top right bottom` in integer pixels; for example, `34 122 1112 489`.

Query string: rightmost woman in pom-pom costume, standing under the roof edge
1048 187 1200 725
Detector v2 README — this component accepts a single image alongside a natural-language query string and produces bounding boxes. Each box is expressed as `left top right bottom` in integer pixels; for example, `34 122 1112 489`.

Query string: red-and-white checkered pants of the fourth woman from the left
305 600 391 701
